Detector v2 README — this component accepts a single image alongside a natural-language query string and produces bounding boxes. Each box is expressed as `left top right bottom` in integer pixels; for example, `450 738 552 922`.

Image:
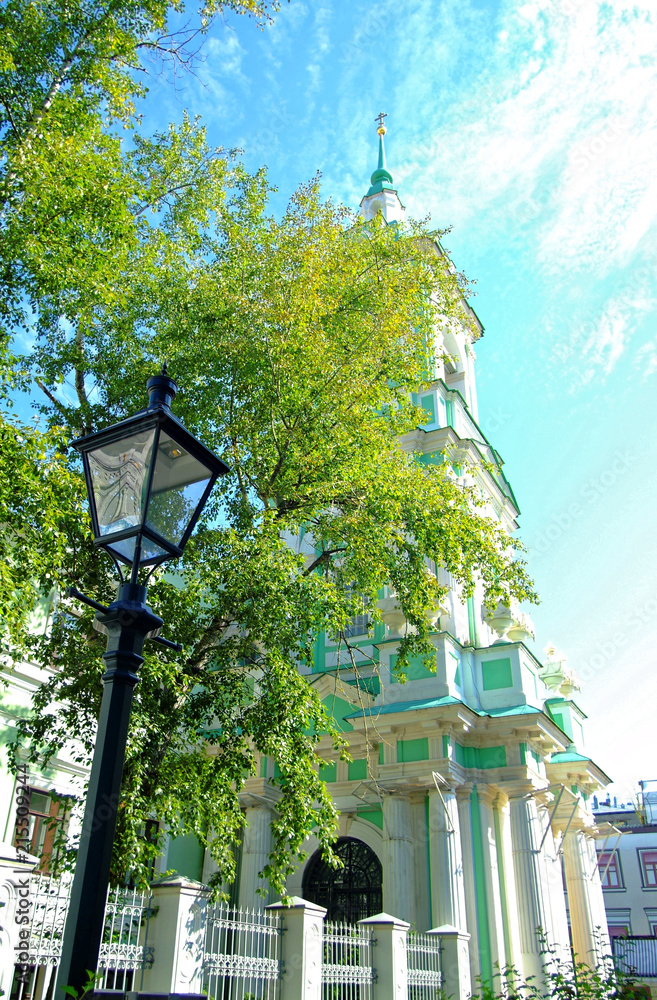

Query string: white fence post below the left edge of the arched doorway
267 896 326 1000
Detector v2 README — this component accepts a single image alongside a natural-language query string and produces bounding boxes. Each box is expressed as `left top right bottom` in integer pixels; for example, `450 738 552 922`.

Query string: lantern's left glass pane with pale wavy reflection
88 428 155 540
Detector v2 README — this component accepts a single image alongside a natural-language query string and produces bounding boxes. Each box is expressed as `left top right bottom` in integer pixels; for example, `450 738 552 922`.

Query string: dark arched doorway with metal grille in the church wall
303 837 383 924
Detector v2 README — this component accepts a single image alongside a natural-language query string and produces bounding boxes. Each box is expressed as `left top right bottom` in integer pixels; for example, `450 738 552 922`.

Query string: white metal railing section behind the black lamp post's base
11 874 153 1000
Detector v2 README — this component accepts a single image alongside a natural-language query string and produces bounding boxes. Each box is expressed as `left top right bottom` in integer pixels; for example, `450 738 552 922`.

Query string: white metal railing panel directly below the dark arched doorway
322 920 374 1000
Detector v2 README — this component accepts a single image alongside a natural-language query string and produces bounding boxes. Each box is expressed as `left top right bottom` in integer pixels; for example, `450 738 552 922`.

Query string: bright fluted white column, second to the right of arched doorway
428 788 466 931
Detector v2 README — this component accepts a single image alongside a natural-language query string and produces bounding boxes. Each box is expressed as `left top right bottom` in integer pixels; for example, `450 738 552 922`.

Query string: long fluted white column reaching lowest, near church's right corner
509 791 550 983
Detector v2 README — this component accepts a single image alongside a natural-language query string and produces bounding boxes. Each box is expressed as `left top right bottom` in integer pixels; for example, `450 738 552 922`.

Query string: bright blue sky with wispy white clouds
137 0 657 799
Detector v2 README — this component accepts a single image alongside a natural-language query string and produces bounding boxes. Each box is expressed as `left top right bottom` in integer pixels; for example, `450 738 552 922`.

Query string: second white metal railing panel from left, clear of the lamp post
203 903 281 1000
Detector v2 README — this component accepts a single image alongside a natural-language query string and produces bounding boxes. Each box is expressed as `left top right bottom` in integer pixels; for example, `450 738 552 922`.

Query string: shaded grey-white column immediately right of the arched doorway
383 793 415 923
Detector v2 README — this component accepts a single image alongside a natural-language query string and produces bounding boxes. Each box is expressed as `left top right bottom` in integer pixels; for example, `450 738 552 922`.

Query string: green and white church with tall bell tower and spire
228 117 610 985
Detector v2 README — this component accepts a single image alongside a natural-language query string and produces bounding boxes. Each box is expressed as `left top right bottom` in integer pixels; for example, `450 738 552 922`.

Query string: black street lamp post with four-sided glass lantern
55 367 229 1000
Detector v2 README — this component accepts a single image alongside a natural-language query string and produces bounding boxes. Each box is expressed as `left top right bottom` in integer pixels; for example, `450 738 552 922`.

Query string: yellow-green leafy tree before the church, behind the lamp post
7 171 532 891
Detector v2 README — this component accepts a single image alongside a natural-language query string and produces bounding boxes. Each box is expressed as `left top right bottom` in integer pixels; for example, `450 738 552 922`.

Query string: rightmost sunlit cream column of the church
563 830 610 968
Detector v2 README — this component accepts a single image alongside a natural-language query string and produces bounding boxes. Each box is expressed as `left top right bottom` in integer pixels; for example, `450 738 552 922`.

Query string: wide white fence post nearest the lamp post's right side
135 875 209 994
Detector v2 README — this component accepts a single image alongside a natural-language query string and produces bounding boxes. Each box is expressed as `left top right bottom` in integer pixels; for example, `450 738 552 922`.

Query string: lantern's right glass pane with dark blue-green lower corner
146 432 212 545
